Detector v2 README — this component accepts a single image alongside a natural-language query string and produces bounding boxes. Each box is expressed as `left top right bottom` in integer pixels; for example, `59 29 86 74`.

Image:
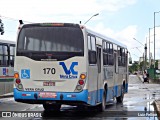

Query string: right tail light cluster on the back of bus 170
75 73 86 92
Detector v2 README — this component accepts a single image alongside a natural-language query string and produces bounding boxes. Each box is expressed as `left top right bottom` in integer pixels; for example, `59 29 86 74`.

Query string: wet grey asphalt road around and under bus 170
0 75 160 120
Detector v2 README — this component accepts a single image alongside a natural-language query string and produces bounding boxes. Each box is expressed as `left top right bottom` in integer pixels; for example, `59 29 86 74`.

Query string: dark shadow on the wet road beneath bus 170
42 104 124 120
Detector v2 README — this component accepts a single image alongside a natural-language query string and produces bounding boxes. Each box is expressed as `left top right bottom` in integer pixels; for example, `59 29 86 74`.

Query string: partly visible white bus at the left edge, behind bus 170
0 40 15 82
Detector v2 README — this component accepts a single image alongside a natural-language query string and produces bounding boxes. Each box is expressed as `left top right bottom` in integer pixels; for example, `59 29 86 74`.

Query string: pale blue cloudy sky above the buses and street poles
0 0 160 61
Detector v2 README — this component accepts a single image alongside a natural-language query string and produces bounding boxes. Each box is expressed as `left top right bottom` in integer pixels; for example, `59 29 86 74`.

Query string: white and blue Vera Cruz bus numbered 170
14 23 128 111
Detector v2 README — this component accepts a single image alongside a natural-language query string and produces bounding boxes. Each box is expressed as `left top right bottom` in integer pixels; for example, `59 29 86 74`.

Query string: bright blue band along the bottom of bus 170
14 84 128 105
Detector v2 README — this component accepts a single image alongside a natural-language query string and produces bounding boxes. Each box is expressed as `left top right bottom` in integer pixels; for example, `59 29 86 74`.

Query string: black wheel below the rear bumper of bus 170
43 103 61 111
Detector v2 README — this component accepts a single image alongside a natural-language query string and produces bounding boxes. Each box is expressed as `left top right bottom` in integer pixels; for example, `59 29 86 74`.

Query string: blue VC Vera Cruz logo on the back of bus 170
59 62 78 79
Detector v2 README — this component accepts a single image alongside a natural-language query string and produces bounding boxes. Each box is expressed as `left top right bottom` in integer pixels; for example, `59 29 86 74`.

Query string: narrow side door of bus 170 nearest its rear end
97 46 102 102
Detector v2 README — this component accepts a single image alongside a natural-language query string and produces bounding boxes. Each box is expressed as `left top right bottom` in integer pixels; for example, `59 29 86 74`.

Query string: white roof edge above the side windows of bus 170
86 28 127 48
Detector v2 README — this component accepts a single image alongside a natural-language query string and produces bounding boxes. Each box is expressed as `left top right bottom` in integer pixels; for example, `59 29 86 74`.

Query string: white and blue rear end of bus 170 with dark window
14 23 88 110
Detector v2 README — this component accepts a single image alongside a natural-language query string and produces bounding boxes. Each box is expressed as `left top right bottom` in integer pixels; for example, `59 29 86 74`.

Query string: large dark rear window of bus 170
17 25 84 60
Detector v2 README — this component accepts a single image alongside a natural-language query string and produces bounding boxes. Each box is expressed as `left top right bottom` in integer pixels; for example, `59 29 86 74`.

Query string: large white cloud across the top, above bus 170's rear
0 0 136 22
